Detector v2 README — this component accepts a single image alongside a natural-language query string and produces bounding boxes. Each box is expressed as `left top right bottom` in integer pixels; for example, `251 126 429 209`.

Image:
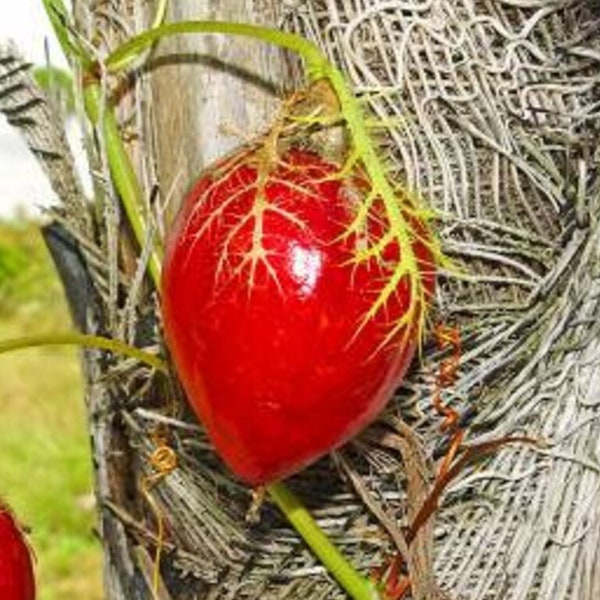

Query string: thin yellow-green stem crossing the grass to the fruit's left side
0 331 167 372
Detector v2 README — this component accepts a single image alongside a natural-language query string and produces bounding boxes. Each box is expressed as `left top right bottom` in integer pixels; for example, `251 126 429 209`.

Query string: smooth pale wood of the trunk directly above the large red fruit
145 0 289 214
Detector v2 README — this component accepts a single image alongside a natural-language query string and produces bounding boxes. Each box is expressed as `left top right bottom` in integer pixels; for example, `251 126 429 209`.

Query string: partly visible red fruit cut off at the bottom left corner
0 501 35 600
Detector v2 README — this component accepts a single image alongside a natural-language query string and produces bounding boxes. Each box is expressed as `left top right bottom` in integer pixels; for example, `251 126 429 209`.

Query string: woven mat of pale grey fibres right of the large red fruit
286 0 600 600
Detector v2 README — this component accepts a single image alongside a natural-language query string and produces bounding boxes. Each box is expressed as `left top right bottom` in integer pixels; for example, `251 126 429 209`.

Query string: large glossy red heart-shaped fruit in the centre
162 149 433 485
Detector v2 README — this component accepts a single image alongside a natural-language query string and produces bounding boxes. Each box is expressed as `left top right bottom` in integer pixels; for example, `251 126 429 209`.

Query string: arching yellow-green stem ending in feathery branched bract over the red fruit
104 21 445 344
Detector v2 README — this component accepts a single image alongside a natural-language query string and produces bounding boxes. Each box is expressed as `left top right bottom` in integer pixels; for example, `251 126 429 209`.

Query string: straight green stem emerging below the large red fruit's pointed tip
267 482 379 600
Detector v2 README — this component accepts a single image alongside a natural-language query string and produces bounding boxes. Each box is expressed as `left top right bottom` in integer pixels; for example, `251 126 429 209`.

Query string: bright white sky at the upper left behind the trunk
0 0 65 218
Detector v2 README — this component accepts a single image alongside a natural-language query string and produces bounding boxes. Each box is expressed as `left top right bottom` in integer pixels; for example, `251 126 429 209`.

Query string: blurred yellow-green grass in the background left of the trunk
0 222 102 600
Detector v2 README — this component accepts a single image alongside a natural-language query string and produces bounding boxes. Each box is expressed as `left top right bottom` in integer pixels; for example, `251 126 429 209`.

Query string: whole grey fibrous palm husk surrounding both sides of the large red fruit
2 0 600 600
